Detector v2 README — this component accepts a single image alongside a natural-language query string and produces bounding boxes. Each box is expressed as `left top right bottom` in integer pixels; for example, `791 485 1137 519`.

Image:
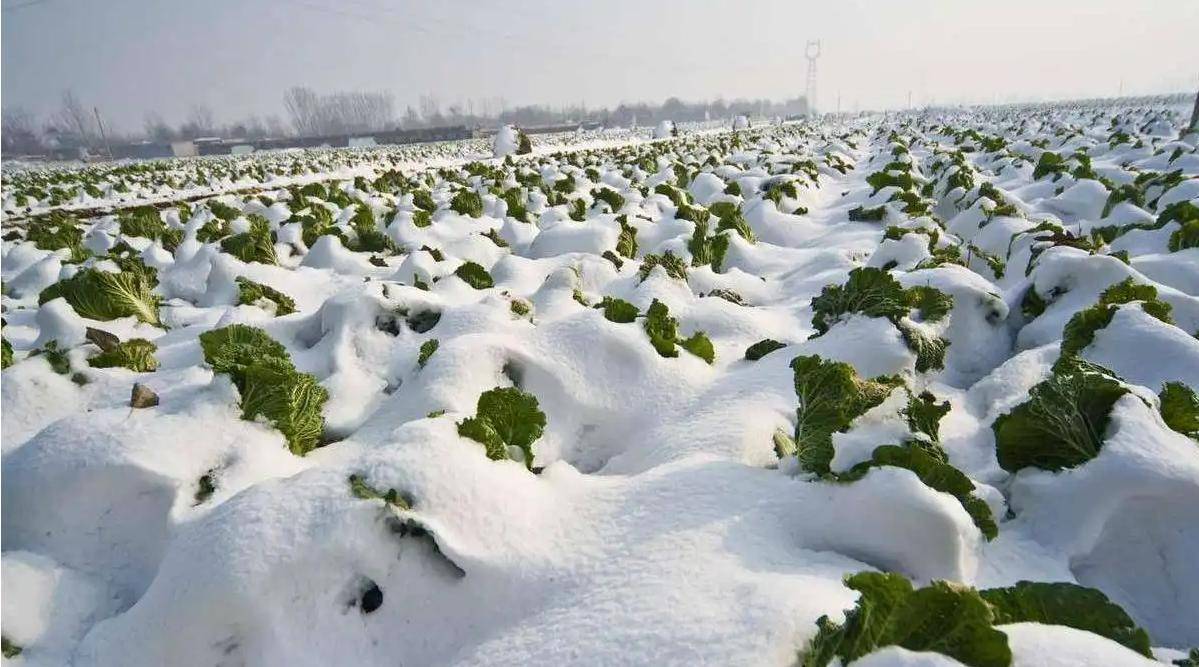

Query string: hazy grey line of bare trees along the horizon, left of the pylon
0 86 807 155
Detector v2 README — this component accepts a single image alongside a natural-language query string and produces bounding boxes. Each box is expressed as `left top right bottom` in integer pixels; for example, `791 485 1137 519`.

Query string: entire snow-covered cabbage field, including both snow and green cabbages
2 103 1199 667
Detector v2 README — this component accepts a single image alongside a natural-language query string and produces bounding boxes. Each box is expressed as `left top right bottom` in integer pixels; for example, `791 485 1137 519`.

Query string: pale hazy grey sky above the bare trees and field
7 0 1199 130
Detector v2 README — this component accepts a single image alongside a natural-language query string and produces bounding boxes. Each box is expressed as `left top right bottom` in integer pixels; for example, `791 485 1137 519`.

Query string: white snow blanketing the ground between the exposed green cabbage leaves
0 103 1199 667
